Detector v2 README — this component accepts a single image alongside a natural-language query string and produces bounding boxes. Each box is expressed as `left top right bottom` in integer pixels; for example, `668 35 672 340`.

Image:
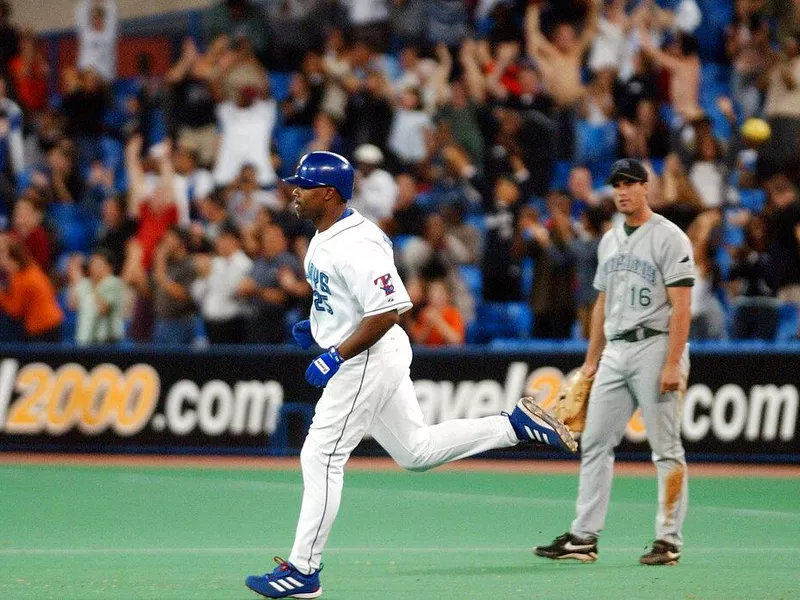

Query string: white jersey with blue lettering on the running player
305 209 412 348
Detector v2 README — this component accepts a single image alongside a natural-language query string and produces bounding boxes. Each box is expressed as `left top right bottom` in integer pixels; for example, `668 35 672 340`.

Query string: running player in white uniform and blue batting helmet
246 152 577 598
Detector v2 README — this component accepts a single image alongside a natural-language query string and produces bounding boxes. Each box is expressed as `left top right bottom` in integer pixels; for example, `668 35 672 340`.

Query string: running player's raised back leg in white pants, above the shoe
369 376 519 471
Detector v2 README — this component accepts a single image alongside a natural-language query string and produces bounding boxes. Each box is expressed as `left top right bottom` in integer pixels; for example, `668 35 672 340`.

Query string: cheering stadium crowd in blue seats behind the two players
0 0 800 346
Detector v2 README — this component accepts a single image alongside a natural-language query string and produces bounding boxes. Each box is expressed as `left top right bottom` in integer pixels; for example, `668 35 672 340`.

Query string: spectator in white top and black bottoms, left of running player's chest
192 225 253 344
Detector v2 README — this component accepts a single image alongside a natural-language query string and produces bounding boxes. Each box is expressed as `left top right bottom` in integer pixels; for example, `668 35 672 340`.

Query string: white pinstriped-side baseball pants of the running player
289 327 518 573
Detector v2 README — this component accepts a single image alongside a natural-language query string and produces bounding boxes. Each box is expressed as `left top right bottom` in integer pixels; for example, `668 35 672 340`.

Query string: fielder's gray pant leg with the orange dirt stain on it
631 336 689 550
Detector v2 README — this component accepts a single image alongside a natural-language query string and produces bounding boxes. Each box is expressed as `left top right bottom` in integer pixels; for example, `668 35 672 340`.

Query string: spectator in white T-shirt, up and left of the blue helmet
214 87 277 187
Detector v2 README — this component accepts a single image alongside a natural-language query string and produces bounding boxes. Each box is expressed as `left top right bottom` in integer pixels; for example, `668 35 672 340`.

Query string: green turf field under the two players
0 466 800 600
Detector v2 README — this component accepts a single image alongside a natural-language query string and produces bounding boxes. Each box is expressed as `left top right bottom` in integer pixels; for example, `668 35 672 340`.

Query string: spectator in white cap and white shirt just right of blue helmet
350 144 397 224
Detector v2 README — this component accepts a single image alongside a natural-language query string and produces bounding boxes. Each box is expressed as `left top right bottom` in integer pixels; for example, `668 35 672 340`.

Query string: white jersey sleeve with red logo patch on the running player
340 238 412 317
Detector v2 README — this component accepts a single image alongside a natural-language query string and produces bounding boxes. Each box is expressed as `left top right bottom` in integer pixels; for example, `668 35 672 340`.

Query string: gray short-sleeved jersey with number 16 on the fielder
594 214 694 340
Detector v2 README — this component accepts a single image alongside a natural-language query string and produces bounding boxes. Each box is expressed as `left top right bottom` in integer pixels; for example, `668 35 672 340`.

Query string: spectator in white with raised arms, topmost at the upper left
75 0 117 81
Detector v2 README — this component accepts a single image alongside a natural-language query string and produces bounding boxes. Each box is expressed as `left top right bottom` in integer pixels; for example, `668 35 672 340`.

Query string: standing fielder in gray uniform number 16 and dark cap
534 159 694 565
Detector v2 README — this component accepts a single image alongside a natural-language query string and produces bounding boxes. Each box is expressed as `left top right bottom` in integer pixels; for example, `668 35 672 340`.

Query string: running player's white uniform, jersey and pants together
289 210 518 573
